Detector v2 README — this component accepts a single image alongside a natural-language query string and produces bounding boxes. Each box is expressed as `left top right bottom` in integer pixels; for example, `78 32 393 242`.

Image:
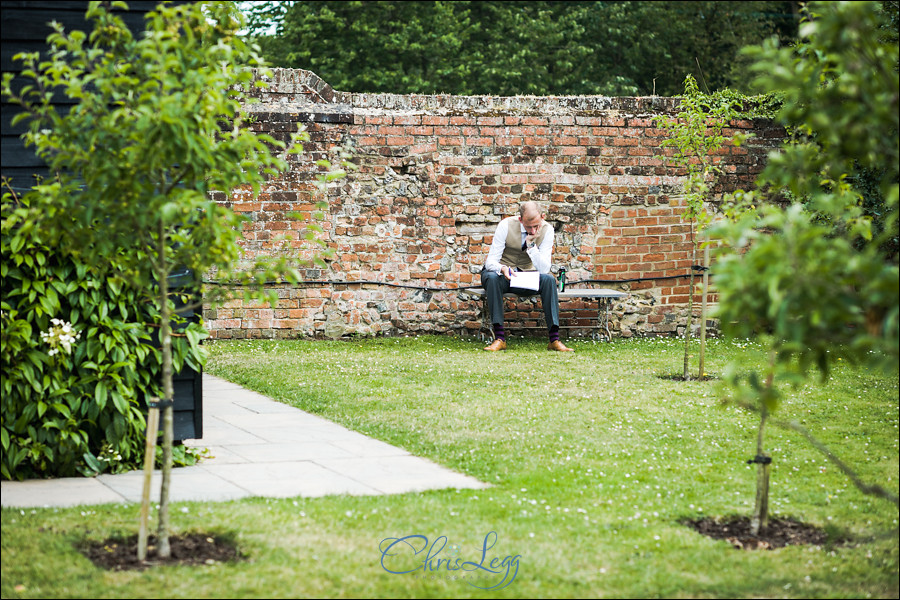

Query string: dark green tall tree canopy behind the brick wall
246 0 798 95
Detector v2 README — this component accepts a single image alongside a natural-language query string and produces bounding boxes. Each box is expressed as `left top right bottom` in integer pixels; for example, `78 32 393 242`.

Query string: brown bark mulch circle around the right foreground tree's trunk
684 517 844 550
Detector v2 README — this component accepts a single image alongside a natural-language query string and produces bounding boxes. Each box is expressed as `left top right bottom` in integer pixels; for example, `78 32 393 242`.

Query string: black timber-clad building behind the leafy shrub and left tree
0 0 203 440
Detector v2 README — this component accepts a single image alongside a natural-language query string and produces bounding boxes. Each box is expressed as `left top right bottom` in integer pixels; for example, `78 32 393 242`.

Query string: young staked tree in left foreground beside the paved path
3 2 334 557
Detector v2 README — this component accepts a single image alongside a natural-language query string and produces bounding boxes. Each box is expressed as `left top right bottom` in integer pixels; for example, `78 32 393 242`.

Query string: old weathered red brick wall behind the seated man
206 69 783 338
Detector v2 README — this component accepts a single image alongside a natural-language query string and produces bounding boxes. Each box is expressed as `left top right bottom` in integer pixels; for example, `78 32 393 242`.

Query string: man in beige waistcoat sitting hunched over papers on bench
481 202 573 352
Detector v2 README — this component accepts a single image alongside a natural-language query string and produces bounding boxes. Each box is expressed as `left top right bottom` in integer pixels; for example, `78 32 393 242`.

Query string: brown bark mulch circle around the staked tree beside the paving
81 533 241 571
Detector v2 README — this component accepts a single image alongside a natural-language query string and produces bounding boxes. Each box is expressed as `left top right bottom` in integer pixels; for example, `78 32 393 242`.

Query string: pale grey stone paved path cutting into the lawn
0 374 488 508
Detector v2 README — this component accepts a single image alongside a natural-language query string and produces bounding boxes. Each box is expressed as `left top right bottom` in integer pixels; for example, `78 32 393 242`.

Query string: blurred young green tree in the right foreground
715 2 900 530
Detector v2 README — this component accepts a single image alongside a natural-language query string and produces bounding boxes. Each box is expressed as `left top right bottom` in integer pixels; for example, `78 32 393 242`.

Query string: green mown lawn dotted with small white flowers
2 337 898 598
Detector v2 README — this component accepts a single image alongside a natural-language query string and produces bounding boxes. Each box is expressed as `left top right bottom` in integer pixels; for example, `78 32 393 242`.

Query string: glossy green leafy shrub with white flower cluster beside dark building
0 199 202 479
